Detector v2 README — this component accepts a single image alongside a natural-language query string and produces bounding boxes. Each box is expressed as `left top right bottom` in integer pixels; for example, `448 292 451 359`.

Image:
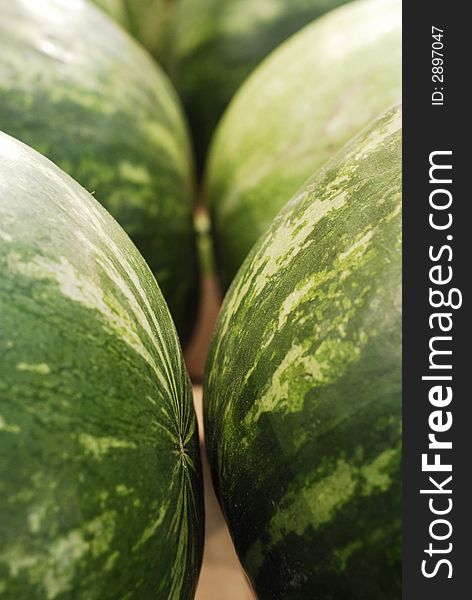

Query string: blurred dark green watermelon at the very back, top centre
167 0 356 167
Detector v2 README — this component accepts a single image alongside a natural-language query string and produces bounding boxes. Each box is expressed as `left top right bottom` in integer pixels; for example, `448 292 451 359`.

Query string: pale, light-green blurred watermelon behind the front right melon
206 0 401 288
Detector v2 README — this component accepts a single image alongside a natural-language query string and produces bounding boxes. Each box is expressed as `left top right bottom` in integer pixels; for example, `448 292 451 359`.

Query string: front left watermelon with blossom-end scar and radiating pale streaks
0 133 203 600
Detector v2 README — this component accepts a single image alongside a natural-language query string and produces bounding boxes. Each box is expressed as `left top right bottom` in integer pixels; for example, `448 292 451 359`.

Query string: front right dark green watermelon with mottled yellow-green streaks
204 108 402 600
